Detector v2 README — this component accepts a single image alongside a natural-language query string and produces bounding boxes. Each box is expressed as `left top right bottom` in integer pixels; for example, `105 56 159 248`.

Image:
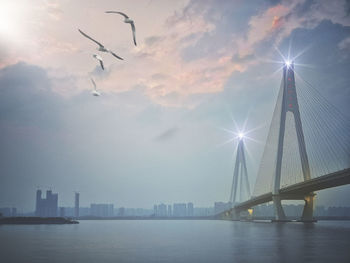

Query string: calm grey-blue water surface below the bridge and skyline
0 220 350 263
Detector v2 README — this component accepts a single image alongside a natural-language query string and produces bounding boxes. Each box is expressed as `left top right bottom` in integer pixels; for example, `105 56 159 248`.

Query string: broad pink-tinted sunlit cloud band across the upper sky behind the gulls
0 0 349 108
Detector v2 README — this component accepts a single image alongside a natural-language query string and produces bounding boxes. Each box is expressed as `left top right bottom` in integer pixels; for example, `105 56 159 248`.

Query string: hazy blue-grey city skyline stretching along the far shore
4 189 350 219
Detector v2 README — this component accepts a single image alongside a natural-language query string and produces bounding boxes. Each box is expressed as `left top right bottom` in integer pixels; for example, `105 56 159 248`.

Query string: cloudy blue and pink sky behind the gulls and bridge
0 0 350 211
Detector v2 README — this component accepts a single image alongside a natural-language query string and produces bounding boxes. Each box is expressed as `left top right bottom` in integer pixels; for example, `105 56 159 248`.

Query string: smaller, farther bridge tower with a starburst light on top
229 135 250 205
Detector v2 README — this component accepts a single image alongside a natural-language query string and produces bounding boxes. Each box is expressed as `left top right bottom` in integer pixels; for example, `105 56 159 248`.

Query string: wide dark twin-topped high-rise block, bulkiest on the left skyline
35 190 58 217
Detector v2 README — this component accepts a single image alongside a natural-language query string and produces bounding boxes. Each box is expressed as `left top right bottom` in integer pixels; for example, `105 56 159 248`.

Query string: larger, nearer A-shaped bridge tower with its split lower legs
272 62 315 221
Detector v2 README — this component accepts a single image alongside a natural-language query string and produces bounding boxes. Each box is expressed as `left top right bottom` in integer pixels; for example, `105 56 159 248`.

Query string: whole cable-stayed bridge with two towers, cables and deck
219 63 350 221
